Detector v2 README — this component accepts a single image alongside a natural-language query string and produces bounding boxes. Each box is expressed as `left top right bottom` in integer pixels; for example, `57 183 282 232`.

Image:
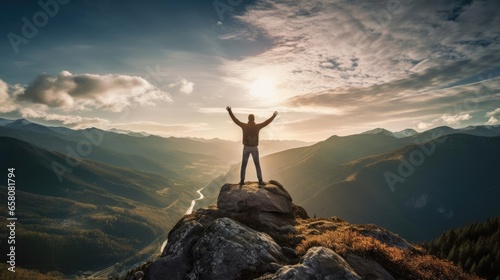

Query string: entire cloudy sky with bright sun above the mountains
0 0 500 141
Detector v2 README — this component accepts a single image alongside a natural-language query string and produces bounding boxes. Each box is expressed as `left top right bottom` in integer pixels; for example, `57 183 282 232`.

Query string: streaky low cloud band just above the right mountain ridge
286 75 500 130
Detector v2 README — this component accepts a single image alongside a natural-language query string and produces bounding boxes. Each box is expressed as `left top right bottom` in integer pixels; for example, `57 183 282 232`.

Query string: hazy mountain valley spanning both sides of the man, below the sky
0 117 500 276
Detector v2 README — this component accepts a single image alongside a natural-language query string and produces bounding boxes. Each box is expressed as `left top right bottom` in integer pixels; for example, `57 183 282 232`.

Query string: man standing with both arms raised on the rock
226 106 278 185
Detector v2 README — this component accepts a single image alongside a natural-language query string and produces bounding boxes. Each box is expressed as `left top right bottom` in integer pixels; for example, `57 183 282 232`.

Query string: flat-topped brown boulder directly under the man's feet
217 182 292 213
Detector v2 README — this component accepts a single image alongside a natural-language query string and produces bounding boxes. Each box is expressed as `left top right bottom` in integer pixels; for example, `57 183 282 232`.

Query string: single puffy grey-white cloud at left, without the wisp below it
17 71 171 112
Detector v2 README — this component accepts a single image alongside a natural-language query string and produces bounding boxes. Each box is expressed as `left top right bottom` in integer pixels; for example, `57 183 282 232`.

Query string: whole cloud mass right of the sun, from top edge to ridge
217 0 500 133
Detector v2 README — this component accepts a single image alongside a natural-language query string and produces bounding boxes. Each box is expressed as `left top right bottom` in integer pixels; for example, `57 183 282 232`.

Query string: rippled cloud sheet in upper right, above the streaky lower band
224 0 500 94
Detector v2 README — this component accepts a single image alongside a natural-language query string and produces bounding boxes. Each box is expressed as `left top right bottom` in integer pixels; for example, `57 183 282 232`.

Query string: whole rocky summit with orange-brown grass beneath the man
143 181 478 280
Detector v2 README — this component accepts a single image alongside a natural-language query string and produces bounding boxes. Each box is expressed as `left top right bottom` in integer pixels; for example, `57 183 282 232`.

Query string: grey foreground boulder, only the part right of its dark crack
188 218 288 280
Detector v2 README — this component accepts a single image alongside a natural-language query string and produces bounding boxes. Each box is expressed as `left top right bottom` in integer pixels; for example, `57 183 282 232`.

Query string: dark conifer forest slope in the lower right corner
422 217 500 280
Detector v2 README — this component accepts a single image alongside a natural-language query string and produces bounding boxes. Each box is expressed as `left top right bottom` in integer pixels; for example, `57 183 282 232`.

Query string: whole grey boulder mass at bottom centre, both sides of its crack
146 217 289 280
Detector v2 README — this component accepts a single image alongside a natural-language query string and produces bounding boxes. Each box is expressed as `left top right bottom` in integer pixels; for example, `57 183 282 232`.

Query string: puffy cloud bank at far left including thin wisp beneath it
0 71 172 127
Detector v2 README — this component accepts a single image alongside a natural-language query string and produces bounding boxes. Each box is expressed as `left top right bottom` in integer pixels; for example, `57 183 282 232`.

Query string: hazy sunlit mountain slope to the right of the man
207 126 500 241
